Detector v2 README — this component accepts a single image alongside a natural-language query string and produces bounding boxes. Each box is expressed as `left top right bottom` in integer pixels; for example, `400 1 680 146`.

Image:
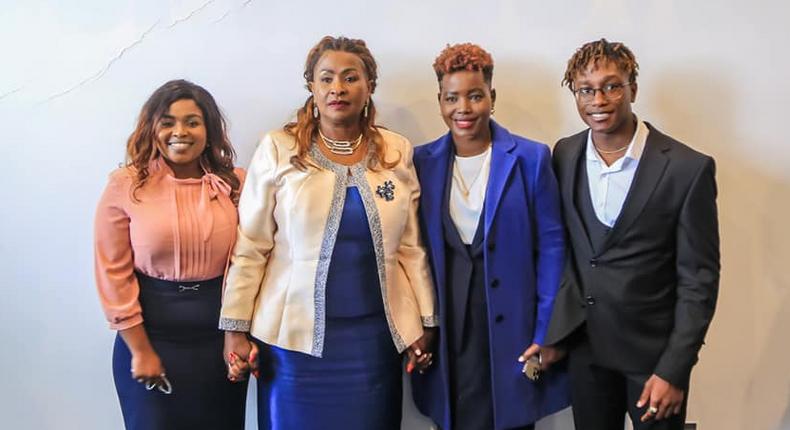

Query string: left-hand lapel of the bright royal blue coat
420 133 453 298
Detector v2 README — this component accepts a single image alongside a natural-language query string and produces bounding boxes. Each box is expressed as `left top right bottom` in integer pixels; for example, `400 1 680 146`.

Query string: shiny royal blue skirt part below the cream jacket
258 314 402 430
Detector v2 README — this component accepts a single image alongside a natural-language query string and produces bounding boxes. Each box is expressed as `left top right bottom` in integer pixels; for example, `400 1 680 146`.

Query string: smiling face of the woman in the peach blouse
156 99 206 178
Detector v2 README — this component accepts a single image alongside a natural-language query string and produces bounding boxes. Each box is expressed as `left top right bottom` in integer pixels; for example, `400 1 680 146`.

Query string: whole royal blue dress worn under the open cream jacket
258 187 402 430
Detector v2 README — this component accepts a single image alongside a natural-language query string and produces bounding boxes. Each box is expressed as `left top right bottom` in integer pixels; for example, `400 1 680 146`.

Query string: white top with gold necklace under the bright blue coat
450 145 491 245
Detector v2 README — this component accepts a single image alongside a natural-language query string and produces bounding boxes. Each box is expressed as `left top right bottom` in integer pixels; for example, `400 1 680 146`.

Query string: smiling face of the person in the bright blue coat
439 70 496 143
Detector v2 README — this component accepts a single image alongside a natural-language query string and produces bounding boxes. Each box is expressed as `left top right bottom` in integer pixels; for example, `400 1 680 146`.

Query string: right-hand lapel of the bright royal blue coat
484 120 516 237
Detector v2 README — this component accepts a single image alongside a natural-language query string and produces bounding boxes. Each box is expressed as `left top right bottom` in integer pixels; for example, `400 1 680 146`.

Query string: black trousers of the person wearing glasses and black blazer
568 327 688 430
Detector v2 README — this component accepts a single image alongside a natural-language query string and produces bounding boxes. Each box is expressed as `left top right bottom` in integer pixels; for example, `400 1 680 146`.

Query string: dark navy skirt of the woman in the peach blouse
113 273 247 430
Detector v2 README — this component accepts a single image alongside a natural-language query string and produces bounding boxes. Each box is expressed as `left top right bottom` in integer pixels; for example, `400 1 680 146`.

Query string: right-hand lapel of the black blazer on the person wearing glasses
600 122 669 253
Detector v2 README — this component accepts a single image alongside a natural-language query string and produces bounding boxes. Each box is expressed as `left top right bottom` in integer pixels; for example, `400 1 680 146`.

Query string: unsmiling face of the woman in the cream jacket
310 51 371 126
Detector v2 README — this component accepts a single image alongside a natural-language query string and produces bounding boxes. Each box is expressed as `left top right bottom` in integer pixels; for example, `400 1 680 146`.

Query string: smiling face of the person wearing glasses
573 61 636 139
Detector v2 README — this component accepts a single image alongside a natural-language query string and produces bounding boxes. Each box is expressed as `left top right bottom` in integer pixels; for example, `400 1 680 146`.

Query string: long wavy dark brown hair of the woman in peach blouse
126 79 241 204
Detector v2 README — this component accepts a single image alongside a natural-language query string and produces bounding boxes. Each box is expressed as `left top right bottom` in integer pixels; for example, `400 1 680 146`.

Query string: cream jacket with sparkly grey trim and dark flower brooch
219 129 438 357
